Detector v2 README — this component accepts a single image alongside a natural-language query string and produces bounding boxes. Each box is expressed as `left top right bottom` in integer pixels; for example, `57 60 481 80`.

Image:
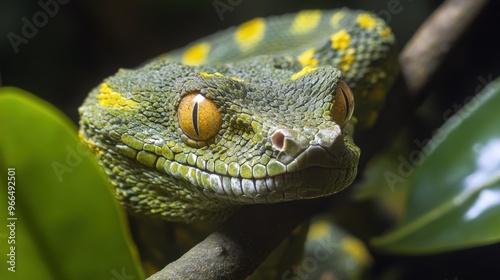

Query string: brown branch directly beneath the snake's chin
149 199 322 280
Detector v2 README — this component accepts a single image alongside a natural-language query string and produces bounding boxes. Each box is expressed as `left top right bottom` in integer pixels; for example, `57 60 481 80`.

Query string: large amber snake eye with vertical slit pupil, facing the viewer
177 93 222 141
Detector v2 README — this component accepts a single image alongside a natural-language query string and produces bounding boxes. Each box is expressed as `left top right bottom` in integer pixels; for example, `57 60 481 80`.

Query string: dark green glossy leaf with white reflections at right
372 77 500 254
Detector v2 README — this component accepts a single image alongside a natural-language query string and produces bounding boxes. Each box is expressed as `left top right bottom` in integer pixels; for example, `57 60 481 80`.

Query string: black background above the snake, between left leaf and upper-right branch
0 0 437 122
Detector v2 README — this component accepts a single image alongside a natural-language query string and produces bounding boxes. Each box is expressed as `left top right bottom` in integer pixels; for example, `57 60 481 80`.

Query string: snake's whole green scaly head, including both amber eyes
80 56 360 221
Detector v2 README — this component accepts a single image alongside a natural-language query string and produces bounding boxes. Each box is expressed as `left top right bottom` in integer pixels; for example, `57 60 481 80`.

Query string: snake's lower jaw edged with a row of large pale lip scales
156 139 359 204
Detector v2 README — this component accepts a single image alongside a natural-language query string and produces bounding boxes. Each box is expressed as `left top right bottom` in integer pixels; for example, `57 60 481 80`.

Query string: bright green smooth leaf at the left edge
0 88 144 279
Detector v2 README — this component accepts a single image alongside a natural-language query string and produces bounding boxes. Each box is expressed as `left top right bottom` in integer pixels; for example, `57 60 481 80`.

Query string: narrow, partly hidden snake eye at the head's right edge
333 81 354 127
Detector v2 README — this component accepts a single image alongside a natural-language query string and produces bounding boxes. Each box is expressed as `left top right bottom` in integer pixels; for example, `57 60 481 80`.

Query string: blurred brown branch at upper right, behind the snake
354 0 488 164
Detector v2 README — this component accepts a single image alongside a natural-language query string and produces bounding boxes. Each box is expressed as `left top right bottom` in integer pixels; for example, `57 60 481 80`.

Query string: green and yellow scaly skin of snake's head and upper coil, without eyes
80 9 395 222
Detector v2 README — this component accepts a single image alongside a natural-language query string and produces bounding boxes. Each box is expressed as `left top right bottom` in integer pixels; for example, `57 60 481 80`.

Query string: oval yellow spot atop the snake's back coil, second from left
235 18 266 51
